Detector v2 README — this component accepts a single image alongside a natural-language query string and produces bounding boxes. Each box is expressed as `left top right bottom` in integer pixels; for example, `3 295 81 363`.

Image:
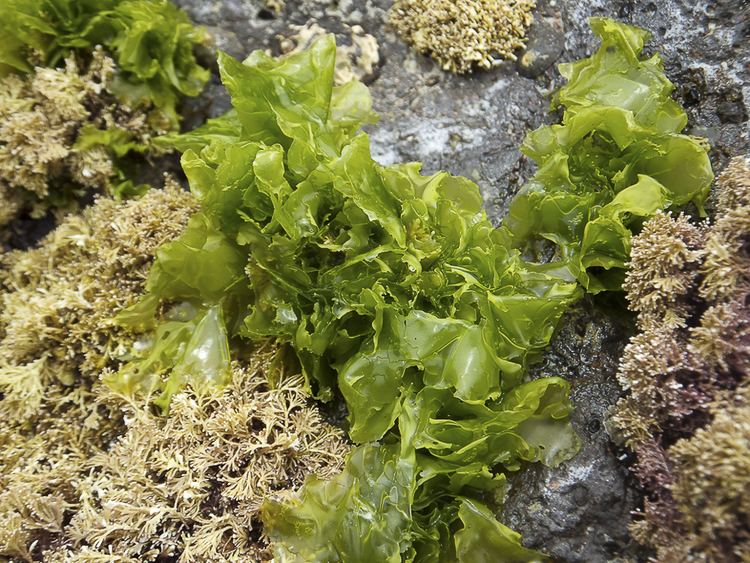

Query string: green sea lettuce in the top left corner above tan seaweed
0 0 209 128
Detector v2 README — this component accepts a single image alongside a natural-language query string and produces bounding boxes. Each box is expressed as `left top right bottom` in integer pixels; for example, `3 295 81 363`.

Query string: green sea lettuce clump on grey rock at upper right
504 18 713 293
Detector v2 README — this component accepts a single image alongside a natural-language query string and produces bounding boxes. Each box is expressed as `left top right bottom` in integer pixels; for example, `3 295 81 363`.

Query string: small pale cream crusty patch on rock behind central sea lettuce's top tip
278 20 380 85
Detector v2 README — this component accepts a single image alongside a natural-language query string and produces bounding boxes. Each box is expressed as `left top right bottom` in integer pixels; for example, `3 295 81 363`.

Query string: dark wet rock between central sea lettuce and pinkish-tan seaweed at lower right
500 300 639 562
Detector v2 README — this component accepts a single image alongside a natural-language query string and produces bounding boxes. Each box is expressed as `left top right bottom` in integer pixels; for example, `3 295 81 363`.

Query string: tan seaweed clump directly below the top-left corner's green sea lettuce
0 49 156 231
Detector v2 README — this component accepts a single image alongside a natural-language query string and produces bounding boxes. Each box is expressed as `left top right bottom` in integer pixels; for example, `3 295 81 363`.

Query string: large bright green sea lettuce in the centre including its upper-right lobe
110 16 711 562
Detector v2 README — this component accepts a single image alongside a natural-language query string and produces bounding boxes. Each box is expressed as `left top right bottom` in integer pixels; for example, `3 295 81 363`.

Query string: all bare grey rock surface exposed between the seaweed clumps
170 0 750 563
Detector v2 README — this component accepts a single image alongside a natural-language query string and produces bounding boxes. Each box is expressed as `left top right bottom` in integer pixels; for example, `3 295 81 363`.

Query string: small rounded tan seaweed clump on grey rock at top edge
390 0 536 74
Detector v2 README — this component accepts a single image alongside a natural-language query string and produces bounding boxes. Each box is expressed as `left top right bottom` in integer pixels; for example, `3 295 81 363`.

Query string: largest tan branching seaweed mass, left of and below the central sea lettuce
0 188 348 561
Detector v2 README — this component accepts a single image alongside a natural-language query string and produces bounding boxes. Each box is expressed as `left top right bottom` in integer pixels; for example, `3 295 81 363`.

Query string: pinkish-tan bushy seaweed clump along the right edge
612 158 750 561
